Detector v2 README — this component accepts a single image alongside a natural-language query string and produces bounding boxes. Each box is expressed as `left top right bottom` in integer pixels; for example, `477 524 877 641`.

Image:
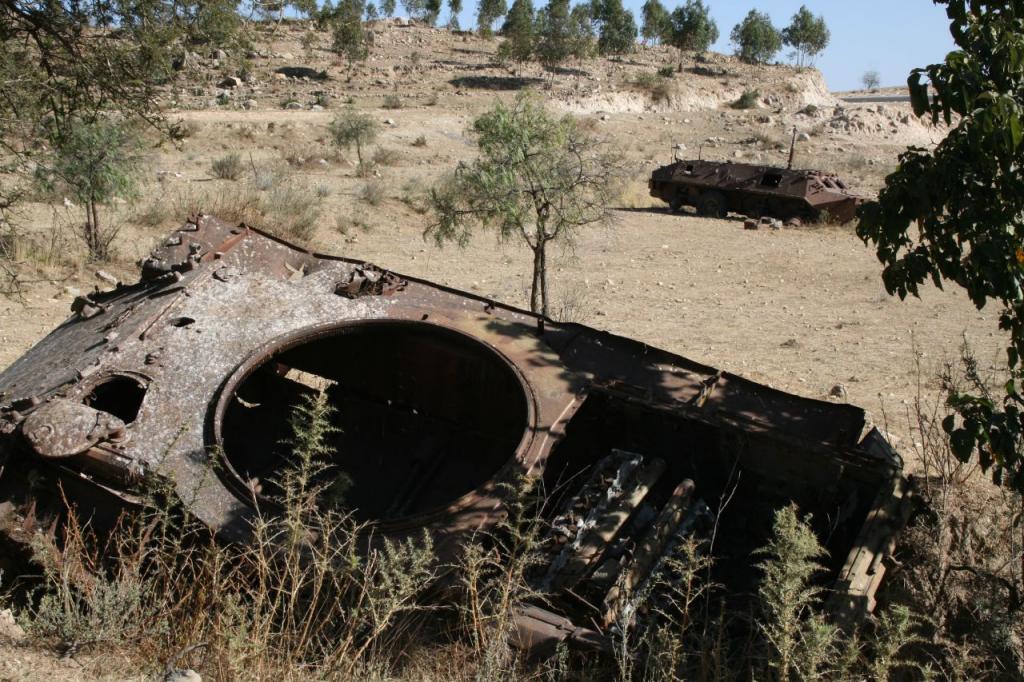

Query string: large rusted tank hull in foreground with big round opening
0 215 906 648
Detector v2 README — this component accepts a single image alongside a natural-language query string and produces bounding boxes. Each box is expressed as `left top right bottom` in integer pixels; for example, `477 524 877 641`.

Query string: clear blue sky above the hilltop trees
448 0 954 91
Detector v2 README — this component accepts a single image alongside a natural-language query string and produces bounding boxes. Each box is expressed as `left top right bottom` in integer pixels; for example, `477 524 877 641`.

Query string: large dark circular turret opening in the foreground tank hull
216 322 529 521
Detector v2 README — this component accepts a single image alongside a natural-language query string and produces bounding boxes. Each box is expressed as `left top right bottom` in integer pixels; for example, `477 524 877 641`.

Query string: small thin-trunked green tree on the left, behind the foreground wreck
36 119 141 260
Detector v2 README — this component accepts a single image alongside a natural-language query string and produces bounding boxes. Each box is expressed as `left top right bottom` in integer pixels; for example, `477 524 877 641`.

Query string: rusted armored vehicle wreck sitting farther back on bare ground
649 160 864 224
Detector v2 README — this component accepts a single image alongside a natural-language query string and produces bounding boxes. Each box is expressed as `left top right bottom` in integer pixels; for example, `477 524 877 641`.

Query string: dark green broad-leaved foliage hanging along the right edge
857 0 1024 491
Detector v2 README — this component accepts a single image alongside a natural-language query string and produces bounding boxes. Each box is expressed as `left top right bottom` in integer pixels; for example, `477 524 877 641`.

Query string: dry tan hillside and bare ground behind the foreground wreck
0 24 1001 450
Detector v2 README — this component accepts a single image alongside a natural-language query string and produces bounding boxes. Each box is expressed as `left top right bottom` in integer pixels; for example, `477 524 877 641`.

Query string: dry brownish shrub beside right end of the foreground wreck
887 342 1024 679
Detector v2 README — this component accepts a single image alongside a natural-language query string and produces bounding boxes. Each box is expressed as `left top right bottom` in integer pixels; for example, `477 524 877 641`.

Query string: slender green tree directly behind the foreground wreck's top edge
427 93 618 314
